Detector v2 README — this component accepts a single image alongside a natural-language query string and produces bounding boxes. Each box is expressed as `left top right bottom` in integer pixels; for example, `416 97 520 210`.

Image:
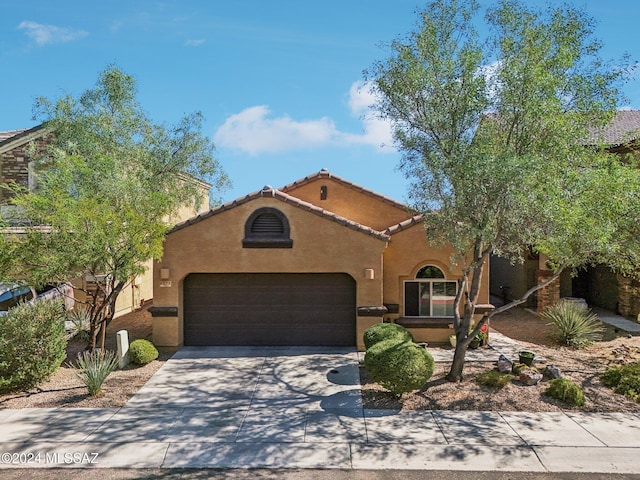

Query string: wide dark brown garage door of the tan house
183 273 356 345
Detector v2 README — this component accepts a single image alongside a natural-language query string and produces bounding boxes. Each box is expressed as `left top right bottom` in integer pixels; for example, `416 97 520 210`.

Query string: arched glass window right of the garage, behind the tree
404 265 457 317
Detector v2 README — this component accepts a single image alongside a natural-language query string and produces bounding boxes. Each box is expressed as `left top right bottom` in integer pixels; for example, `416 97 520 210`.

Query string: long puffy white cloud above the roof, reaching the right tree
214 82 394 155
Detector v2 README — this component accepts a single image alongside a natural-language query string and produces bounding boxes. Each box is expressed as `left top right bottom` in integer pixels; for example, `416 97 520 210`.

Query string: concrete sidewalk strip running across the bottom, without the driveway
0 406 640 474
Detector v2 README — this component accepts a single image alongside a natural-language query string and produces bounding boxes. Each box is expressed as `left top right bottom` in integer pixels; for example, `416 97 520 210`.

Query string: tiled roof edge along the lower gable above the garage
169 185 391 241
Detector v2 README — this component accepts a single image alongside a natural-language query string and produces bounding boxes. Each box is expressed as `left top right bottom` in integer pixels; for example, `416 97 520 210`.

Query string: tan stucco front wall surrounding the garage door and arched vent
153 197 386 346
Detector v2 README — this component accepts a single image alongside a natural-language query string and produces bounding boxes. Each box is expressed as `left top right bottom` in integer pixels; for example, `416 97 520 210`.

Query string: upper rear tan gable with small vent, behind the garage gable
281 170 413 231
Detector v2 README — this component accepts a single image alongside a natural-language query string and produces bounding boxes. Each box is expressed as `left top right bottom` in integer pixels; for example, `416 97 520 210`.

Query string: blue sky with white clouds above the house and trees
0 0 640 201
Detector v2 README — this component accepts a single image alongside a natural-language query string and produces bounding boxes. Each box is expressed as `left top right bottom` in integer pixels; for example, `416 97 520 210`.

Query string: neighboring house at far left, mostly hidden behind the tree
0 125 211 317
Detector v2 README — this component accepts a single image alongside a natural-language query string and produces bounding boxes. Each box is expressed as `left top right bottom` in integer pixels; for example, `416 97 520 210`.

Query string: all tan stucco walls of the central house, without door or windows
153 171 488 348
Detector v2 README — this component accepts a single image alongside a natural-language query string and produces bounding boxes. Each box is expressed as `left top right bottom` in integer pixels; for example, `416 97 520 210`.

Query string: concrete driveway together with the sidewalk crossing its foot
0 349 640 474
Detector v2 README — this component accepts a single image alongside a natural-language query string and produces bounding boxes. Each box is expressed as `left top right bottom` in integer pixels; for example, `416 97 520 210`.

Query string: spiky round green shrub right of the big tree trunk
542 301 604 348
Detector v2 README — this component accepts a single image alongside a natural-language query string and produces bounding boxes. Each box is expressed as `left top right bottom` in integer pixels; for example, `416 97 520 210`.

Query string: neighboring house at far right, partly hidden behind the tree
490 110 640 317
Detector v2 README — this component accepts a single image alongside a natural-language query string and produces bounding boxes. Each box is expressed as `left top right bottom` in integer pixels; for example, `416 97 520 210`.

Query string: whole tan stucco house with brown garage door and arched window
150 170 489 348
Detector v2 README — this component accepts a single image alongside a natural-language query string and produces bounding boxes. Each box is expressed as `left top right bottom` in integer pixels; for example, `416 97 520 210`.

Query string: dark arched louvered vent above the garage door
242 207 293 248
